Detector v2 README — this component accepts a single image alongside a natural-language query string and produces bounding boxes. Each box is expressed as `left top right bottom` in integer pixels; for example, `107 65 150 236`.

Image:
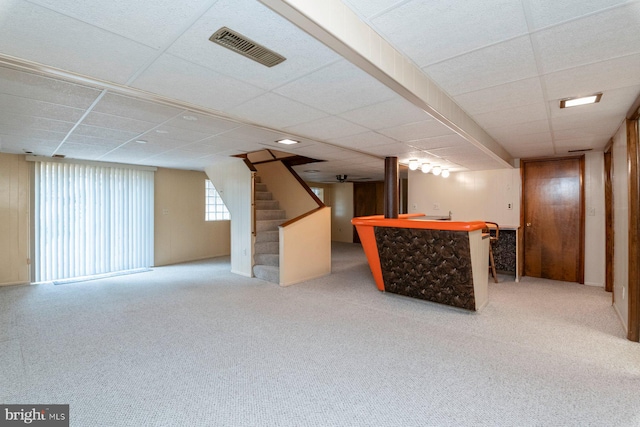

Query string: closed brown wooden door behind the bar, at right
522 157 584 283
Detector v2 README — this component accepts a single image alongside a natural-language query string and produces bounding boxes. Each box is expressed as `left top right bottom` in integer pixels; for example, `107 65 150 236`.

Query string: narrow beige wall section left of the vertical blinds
0 153 31 285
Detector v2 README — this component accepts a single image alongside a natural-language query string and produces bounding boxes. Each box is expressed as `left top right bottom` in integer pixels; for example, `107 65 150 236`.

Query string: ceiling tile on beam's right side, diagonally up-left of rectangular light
423 36 538 96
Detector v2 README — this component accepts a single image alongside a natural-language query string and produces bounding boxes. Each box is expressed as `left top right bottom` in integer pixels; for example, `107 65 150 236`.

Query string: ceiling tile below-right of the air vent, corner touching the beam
275 60 396 114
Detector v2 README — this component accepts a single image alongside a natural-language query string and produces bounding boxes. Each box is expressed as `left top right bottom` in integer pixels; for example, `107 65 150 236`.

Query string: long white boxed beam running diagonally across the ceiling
260 0 513 167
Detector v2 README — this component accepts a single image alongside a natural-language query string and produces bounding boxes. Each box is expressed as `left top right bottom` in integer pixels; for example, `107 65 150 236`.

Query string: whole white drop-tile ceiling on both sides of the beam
0 0 640 181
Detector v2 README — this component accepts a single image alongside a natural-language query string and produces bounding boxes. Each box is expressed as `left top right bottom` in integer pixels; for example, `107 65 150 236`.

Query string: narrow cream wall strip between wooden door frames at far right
611 123 629 331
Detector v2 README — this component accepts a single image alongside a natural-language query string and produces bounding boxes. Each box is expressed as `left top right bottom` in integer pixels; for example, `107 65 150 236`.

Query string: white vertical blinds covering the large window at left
34 161 154 282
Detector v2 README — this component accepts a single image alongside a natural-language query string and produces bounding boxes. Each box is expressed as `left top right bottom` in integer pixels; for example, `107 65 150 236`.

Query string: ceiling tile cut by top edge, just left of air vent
31 0 215 49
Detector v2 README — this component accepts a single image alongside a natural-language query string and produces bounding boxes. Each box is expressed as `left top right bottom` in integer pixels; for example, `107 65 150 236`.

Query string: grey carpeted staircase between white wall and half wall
253 176 286 283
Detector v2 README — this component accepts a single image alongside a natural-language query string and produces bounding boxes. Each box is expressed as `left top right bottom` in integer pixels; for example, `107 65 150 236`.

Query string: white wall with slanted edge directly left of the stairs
205 157 253 277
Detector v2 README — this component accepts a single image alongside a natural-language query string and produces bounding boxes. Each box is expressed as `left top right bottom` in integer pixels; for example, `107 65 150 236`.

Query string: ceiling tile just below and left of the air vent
132 54 263 111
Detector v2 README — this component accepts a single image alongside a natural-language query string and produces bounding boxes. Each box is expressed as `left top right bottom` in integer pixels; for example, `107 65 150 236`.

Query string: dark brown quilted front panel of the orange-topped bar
374 227 475 310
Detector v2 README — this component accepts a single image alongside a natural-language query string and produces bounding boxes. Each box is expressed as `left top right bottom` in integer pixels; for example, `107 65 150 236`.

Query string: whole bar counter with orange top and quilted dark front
351 214 489 311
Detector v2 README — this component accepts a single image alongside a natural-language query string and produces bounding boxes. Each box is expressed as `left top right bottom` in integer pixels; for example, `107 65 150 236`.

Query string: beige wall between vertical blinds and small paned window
154 168 230 265
